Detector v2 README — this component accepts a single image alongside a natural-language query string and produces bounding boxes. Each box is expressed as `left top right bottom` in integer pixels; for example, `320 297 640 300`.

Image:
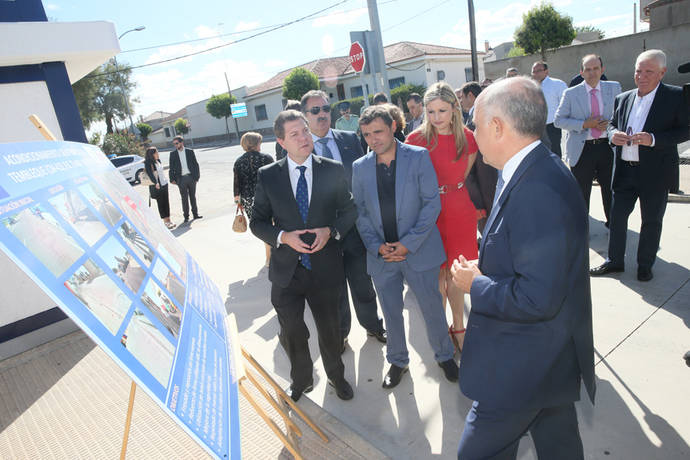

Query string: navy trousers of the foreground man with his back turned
458 400 584 460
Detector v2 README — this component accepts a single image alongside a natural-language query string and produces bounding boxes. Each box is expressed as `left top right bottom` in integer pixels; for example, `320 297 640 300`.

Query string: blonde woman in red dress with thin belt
405 82 477 351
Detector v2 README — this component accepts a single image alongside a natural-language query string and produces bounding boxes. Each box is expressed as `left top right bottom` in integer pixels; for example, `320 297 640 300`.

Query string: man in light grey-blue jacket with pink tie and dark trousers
553 54 621 228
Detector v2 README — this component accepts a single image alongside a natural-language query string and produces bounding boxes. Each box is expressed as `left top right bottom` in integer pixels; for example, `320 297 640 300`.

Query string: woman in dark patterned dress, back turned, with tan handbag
233 131 273 265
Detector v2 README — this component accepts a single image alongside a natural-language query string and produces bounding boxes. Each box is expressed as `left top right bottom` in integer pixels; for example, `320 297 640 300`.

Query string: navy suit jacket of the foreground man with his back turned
460 144 595 410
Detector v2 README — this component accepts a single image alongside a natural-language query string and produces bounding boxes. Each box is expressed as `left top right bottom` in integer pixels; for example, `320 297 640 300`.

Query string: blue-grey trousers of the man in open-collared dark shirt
373 261 455 367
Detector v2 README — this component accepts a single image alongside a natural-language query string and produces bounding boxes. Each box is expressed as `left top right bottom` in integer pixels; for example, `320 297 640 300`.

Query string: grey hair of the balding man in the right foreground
475 77 547 138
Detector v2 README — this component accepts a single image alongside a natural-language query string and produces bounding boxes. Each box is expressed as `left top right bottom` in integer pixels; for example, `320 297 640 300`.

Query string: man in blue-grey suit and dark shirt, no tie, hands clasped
352 106 458 388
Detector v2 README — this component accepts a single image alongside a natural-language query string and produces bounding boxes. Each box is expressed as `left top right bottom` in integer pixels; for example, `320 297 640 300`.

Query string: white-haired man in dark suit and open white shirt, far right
590 50 688 281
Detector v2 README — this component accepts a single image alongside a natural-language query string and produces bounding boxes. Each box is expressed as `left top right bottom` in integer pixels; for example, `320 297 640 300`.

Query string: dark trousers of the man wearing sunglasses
340 228 383 338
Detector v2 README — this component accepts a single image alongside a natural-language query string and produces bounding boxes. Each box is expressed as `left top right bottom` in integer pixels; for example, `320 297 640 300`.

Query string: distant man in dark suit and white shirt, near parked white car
169 136 203 222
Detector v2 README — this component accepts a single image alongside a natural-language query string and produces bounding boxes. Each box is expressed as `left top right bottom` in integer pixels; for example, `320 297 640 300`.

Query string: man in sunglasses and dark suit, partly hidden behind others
301 90 386 351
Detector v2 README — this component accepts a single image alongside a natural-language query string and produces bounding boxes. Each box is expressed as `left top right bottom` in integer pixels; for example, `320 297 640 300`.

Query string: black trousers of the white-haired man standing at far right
608 161 668 269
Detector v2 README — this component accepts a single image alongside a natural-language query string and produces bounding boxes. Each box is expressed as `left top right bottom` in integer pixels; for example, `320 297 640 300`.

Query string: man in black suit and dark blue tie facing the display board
250 110 357 401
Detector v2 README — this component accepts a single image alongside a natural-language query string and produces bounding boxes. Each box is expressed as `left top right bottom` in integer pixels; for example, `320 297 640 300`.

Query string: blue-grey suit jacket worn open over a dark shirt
352 141 446 276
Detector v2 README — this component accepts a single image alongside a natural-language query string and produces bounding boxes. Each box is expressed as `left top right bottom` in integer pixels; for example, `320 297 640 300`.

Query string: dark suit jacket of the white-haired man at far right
608 83 688 190
